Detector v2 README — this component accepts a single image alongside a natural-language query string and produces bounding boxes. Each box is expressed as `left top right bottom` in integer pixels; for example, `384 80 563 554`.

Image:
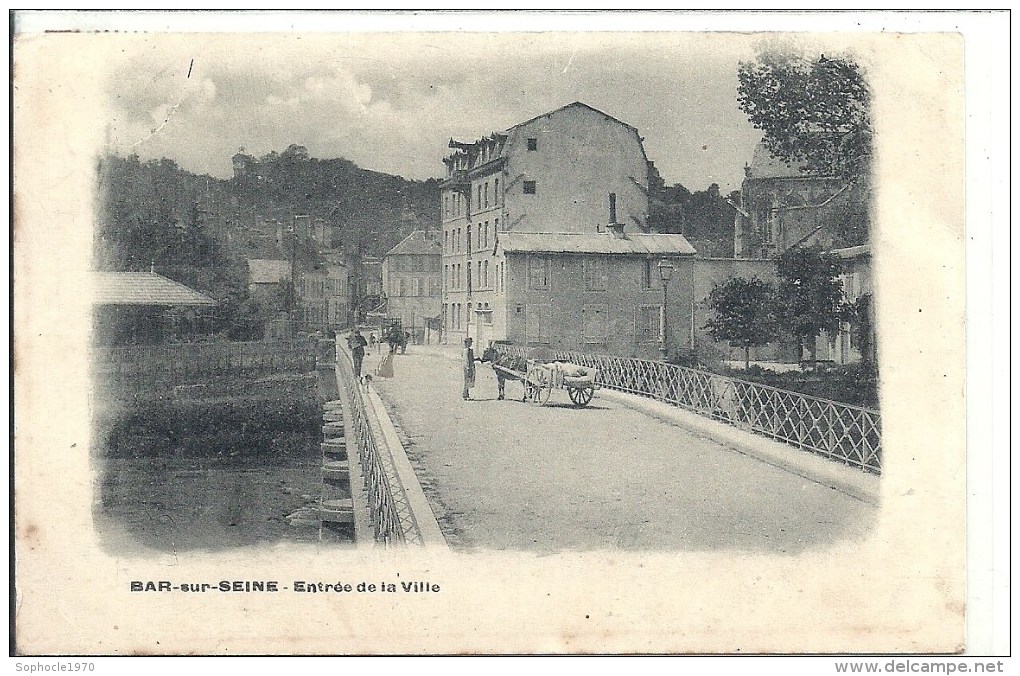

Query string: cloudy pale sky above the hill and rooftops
99 33 761 191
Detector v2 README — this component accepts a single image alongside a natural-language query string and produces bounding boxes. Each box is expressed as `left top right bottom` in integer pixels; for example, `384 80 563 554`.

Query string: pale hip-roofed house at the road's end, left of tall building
383 230 443 343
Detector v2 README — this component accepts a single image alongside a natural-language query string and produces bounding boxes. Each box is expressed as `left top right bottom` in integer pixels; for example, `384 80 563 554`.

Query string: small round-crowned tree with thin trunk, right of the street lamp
705 277 779 368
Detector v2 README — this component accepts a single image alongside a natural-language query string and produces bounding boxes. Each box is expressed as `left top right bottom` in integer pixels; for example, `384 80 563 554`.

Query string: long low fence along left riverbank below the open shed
92 339 317 383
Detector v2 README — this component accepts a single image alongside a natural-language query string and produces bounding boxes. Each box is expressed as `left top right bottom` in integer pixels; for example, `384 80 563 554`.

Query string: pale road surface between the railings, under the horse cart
366 346 875 554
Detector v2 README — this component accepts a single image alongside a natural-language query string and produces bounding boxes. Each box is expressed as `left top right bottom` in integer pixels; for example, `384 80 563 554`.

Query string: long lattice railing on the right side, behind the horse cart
499 346 881 474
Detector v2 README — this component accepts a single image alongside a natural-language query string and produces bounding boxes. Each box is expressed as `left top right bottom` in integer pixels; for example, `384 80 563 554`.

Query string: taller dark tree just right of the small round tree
776 247 848 361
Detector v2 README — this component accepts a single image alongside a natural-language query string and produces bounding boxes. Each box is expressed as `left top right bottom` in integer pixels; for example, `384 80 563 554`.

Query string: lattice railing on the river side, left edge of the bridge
337 349 423 544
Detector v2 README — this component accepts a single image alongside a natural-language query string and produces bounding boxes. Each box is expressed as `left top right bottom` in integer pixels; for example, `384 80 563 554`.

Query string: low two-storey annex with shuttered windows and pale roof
487 231 695 359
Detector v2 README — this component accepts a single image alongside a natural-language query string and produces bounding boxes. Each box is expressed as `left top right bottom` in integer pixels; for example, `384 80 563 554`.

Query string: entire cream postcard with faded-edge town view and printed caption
11 12 1003 656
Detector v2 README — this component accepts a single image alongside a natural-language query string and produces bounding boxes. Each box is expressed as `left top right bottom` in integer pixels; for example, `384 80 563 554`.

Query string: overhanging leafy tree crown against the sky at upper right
736 53 872 183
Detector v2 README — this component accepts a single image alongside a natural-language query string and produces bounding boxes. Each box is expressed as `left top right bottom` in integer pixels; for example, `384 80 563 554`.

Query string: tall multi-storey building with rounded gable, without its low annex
441 103 652 341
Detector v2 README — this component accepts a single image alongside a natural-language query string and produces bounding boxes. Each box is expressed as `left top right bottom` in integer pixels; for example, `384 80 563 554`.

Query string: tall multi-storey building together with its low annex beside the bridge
441 103 695 356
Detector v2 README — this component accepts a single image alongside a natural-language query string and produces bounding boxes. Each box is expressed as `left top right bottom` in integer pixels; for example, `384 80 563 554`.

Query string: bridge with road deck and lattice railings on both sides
337 346 879 554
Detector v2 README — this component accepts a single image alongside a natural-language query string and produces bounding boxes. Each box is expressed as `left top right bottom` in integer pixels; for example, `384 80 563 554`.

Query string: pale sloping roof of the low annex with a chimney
498 232 698 256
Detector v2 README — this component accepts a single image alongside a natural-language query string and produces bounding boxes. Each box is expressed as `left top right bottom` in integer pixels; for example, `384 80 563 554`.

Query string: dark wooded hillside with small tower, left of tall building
95 146 439 270
